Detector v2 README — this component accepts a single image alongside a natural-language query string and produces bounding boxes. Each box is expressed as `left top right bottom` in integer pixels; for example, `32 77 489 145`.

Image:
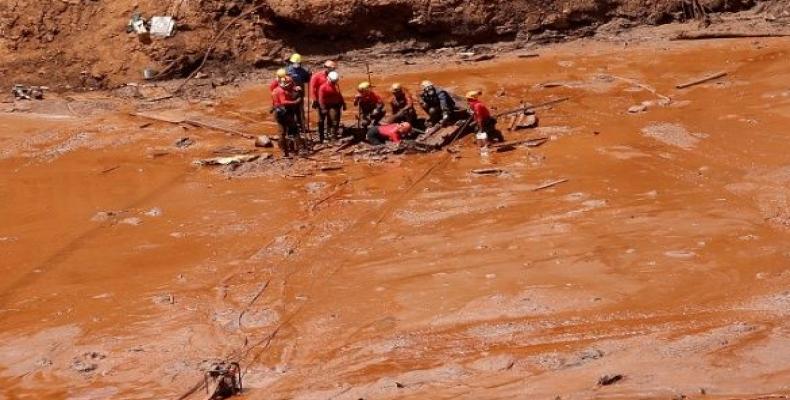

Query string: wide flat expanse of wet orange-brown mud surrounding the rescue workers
0 40 790 399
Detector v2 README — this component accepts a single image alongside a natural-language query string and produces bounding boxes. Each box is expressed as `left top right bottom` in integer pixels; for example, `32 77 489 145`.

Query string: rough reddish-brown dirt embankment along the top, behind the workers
0 0 778 89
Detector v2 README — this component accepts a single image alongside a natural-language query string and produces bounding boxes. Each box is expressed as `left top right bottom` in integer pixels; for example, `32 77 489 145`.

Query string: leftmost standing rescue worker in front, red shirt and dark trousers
272 77 303 157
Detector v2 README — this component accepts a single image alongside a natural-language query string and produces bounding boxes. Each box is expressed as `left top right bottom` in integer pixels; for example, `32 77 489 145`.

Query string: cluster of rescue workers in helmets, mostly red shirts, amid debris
269 54 504 157
